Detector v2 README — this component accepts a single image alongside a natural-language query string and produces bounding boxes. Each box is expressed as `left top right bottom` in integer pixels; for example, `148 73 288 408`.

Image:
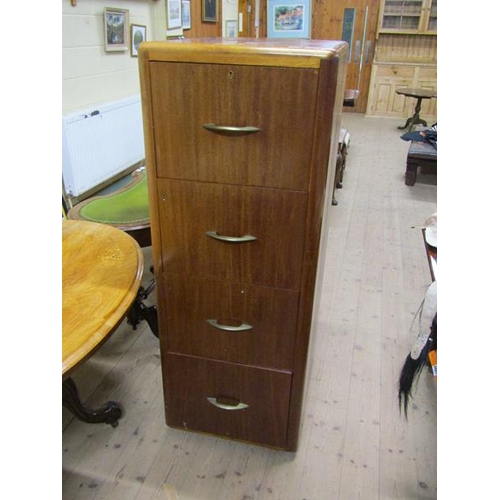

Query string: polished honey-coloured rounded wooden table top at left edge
62 220 144 379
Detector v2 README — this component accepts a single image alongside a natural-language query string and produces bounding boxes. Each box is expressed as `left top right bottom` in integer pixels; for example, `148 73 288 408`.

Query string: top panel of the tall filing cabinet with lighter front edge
139 38 348 67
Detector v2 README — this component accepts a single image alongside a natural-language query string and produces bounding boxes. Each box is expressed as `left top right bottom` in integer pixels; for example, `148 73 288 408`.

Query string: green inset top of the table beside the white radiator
80 173 149 224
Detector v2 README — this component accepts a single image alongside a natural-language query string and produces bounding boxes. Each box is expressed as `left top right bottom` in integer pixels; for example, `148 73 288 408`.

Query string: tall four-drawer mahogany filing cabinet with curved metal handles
139 38 347 451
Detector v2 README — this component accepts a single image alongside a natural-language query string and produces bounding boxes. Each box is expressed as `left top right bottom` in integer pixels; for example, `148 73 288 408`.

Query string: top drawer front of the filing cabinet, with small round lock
151 63 318 191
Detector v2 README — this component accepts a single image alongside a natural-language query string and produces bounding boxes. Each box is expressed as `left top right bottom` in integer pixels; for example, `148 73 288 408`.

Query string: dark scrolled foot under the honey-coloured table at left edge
62 377 123 427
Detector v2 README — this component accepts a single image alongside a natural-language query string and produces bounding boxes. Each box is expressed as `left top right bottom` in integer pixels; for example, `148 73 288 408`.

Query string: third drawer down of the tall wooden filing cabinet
161 275 299 370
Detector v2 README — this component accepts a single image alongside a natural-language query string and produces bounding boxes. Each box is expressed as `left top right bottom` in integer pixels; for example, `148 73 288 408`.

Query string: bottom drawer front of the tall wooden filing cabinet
163 354 291 448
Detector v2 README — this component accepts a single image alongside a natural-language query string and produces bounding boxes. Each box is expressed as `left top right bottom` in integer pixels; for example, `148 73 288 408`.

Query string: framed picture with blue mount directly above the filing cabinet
267 0 311 38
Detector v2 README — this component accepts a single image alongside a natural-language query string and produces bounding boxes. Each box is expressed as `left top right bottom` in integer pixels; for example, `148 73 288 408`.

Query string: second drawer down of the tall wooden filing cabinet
158 179 307 290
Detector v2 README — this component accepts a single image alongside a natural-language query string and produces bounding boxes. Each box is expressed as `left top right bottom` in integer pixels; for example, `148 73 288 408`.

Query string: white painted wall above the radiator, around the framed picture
62 0 165 114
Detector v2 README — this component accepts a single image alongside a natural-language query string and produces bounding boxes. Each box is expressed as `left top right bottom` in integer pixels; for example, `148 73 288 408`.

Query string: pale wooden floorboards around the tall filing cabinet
62 113 437 500
